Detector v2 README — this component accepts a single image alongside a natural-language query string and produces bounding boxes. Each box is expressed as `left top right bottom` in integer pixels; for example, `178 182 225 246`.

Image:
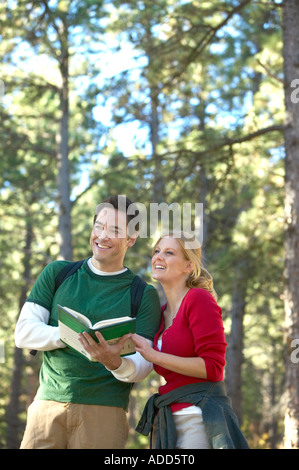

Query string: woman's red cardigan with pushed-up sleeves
154 288 227 411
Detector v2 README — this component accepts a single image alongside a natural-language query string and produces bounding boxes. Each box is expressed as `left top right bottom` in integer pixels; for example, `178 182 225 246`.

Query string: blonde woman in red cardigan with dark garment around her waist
133 233 248 449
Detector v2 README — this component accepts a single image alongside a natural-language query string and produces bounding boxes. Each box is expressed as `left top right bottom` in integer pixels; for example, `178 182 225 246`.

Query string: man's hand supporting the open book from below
79 331 131 370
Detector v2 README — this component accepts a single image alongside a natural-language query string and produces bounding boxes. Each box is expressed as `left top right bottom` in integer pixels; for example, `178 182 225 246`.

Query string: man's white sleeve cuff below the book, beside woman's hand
108 340 153 382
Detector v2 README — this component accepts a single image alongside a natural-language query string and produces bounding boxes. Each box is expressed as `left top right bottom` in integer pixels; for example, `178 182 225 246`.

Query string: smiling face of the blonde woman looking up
152 237 192 284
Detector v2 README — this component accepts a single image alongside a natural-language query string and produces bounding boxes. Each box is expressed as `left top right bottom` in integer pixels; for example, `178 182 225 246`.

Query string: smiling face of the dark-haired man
90 207 136 272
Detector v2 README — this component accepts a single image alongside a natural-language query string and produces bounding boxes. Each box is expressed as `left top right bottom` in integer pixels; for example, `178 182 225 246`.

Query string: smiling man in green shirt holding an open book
15 196 160 449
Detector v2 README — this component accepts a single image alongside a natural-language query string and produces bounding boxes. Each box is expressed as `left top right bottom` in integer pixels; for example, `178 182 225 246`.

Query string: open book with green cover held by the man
57 304 136 361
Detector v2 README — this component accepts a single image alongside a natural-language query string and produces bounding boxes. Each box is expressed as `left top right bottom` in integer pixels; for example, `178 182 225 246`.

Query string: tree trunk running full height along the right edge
283 0 299 449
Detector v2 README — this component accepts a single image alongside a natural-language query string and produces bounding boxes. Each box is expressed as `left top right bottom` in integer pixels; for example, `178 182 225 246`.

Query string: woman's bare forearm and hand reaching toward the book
132 334 207 379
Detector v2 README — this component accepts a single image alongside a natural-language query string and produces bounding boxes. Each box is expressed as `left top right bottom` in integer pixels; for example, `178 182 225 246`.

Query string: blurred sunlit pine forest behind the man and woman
0 0 299 449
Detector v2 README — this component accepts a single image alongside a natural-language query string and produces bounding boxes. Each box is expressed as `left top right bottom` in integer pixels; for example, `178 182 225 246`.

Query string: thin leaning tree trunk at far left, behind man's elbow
6 215 33 449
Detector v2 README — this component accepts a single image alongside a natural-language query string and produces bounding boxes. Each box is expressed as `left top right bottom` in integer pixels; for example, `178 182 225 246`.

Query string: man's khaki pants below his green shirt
21 400 128 449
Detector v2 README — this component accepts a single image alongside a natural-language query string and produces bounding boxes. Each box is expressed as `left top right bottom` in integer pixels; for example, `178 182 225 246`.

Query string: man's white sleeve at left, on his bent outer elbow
15 302 66 351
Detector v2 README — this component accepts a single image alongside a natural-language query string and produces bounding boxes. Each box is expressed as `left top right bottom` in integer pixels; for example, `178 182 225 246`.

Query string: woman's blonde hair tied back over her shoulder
152 231 217 299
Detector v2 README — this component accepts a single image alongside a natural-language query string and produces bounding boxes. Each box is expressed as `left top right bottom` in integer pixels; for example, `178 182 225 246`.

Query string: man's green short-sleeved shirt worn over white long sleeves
27 260 161 410
